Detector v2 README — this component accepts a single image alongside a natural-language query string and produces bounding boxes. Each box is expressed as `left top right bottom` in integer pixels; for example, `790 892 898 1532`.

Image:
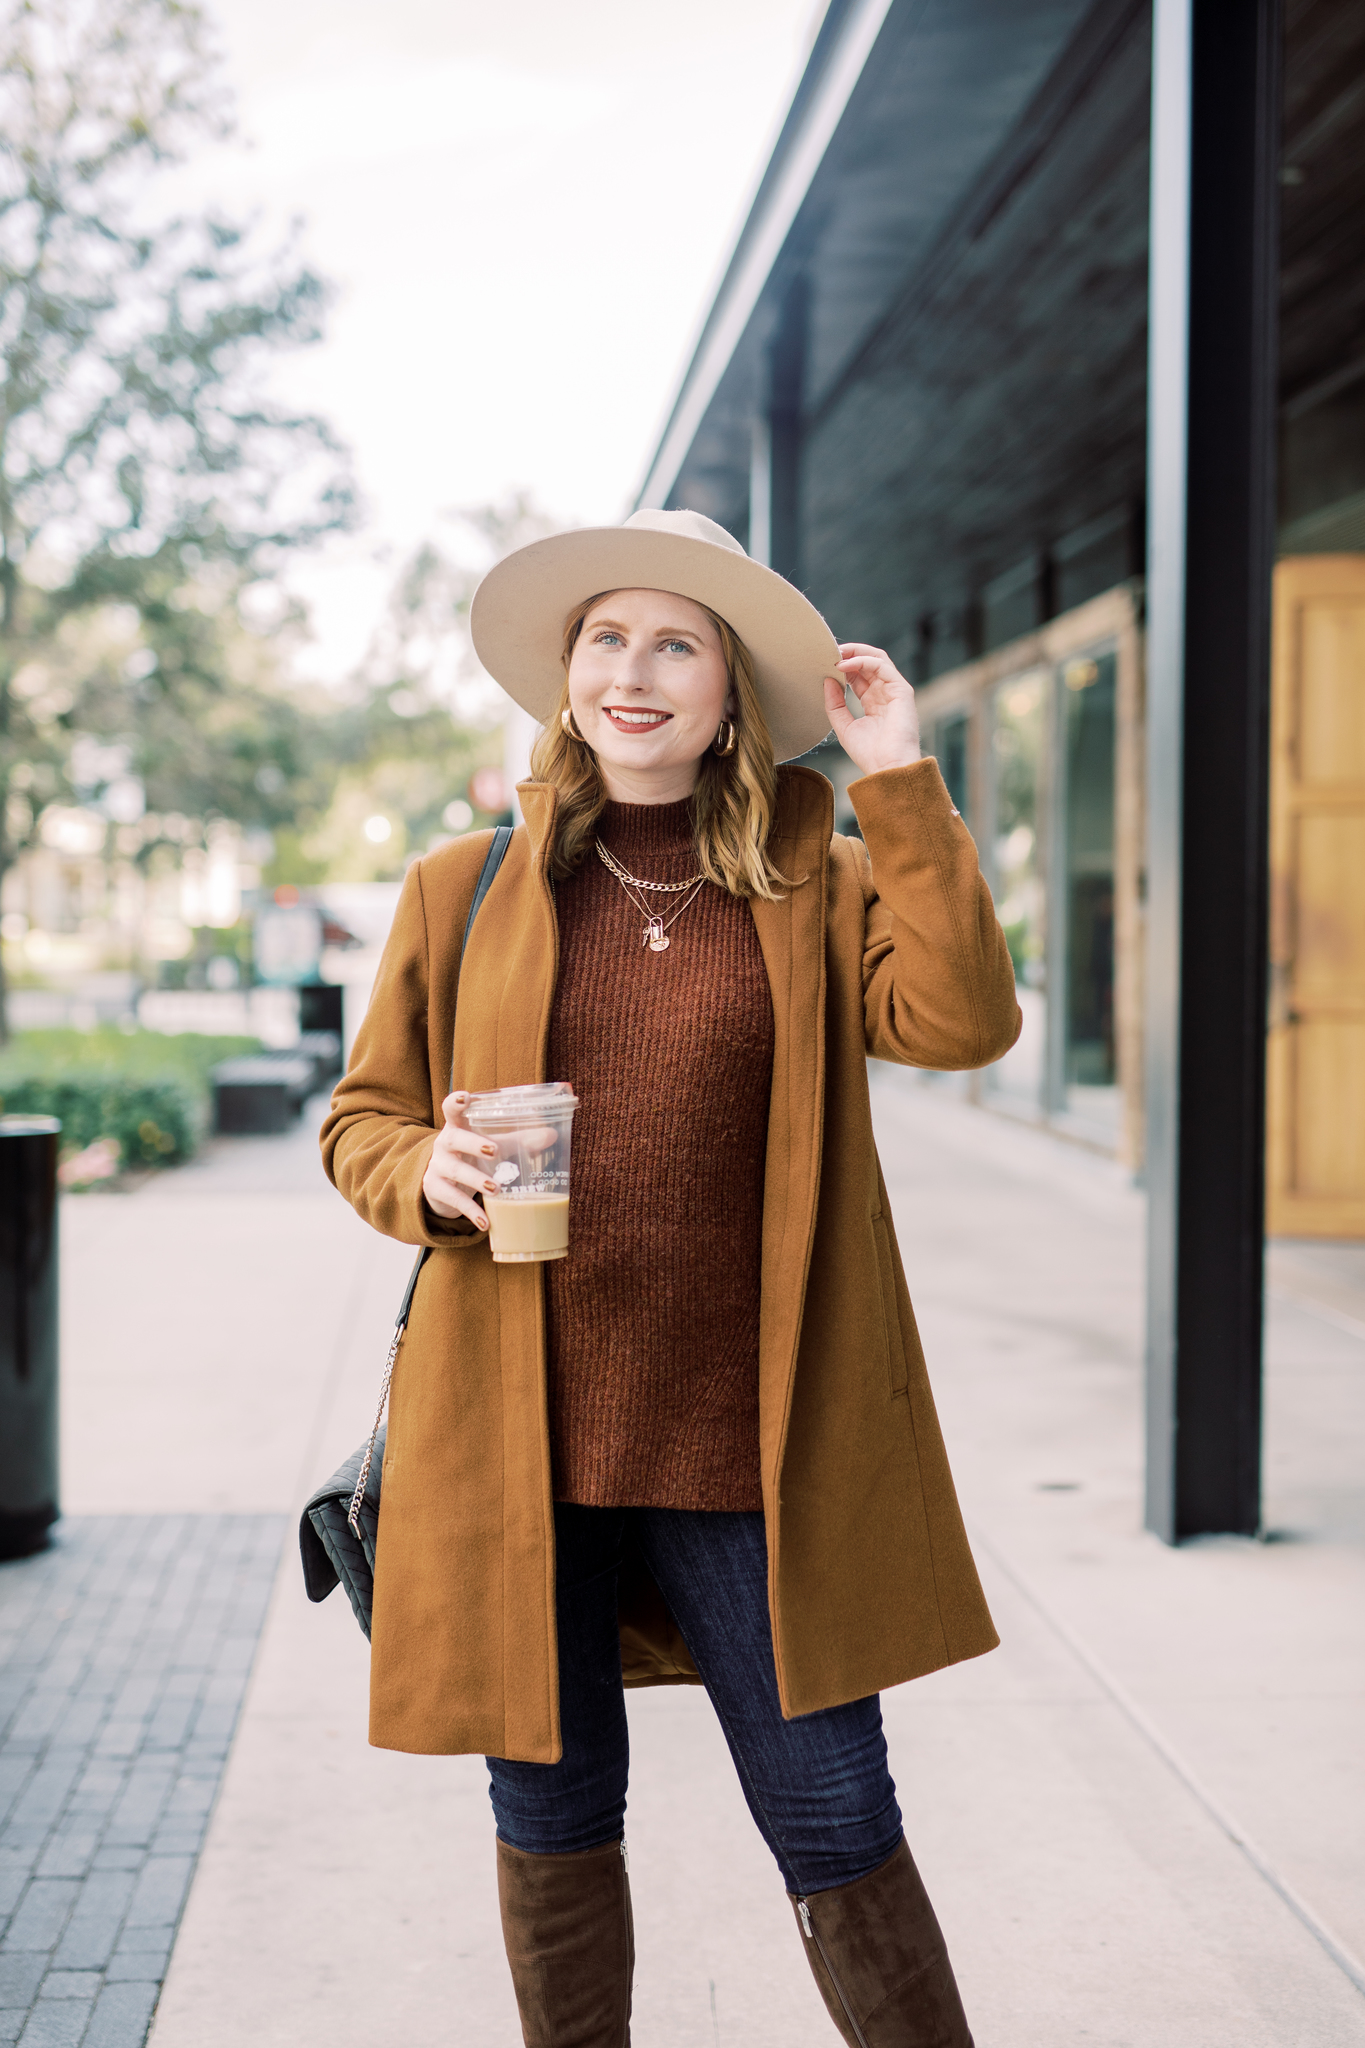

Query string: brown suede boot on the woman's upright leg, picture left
497 1839 634 2048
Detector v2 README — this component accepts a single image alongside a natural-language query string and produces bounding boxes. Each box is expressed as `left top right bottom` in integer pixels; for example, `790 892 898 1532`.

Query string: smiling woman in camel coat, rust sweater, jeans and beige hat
323 512 1019 2048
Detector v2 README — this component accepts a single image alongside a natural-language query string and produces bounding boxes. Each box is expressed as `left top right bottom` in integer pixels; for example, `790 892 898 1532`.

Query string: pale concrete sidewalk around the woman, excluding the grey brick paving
0 1069 1365 2048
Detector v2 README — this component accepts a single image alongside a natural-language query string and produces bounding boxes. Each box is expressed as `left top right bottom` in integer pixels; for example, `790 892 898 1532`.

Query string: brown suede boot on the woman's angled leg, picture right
788 1835 972 2048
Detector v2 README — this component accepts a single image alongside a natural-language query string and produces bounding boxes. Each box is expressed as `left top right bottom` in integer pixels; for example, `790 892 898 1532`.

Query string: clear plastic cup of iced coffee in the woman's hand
465 1081 579 1266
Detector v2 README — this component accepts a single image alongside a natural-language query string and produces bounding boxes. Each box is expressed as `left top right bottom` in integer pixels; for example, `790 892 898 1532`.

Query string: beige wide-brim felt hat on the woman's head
469 512 839 762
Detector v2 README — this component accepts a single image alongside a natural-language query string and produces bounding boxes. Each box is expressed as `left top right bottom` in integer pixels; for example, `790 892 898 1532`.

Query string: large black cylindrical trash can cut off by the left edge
0 1116 61 1556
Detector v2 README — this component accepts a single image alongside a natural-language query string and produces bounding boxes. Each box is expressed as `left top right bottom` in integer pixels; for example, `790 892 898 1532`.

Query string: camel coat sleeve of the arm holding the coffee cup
321 860 483 1245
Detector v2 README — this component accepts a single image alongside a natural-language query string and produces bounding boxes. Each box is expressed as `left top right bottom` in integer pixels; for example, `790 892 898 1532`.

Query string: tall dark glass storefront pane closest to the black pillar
1060 653 1117 1116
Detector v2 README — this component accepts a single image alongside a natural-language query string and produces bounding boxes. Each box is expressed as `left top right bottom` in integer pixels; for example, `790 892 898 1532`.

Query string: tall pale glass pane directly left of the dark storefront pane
990 668 1052 1104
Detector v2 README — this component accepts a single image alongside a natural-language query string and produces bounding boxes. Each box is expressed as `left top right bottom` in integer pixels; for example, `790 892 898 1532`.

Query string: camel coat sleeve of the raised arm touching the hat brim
849 760 1023 1069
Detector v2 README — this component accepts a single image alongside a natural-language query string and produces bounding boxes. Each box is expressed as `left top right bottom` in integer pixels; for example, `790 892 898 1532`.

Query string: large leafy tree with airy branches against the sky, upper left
0 0 354 1030
